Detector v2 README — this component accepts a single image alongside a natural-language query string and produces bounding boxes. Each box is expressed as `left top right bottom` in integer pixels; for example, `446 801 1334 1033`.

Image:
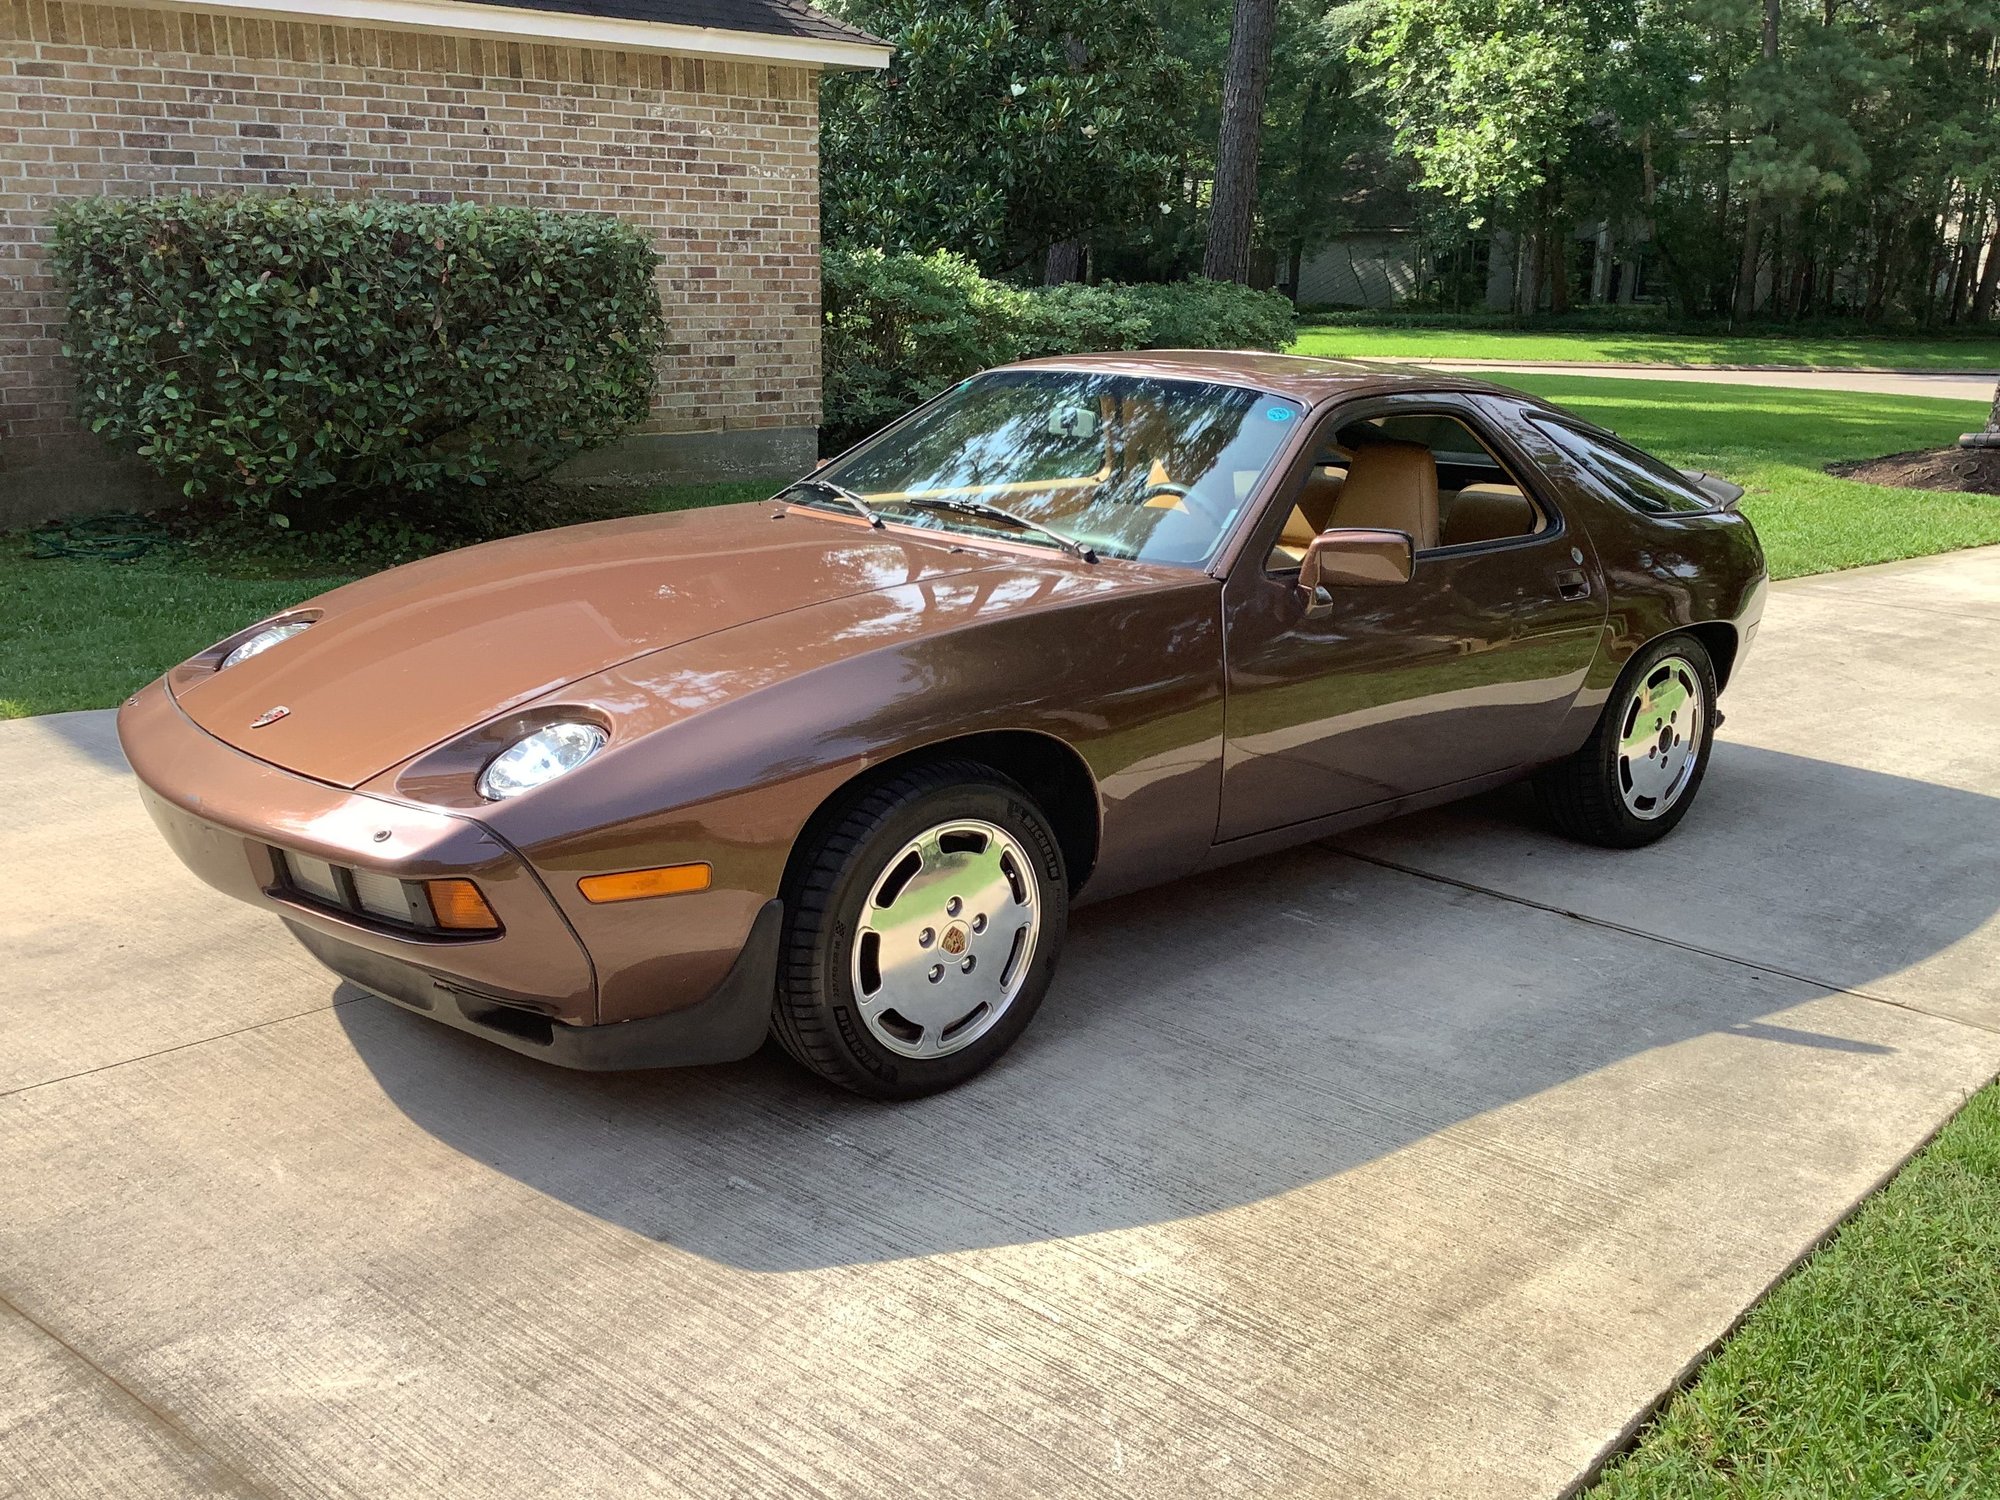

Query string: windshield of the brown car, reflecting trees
804 370 1302 566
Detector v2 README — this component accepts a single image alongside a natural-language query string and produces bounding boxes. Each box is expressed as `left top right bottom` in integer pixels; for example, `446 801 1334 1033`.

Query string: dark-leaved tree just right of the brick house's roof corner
820 0 1190 280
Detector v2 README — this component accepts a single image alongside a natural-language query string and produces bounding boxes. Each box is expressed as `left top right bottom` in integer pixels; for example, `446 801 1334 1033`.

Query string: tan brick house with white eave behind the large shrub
0 0 888 526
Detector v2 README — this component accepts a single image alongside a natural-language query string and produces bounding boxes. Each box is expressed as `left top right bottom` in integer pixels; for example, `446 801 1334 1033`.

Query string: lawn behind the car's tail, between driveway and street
1500 376 2000 578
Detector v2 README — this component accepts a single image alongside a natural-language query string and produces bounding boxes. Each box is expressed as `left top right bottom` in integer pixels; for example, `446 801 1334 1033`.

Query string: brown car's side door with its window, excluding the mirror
1218 394 1606 840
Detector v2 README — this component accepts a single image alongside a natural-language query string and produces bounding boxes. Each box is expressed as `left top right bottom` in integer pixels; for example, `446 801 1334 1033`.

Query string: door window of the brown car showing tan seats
1264 412 1548 572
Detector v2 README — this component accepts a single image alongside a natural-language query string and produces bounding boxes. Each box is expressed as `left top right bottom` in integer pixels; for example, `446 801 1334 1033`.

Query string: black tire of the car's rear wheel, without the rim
1534 636 1716 848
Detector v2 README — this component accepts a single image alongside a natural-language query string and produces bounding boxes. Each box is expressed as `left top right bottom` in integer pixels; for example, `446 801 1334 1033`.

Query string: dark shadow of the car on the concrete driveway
336 746 2000 1270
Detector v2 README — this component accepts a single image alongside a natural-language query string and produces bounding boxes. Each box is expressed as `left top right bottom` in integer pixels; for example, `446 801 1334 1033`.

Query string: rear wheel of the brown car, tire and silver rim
1534 636 1716 848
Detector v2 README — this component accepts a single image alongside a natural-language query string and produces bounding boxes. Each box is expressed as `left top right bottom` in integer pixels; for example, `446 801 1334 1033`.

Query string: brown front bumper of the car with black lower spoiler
118 682 778 1068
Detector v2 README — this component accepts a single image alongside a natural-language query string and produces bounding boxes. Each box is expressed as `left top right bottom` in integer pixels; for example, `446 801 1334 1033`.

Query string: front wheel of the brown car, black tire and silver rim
772 762 1068 1098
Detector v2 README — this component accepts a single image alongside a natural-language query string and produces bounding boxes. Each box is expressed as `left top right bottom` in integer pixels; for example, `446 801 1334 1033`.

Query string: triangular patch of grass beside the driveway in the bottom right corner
1588 1086 2000 1500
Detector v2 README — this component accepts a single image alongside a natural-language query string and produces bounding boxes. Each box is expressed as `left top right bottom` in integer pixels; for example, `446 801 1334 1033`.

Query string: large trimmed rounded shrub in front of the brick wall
54 196 664 522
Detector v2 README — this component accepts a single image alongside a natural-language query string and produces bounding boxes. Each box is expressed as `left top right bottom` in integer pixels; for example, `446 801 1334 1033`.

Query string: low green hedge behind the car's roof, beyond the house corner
822 248 1298 450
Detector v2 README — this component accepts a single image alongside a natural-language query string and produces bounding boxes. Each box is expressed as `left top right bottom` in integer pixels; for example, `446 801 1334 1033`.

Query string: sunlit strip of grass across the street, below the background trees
1292 324 2000 370
